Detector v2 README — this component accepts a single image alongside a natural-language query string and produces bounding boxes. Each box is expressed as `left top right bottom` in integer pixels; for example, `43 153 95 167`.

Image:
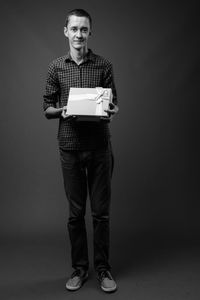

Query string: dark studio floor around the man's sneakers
0 237 200 300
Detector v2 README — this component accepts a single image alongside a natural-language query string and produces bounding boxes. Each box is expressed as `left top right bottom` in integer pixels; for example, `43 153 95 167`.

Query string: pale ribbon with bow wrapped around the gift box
70 87 109 115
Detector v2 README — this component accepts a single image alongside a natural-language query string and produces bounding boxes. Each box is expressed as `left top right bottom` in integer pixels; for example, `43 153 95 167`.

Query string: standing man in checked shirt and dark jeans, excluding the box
43 9 118 292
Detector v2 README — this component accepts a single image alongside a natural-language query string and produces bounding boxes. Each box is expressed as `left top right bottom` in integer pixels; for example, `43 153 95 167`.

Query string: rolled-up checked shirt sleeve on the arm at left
43 63 60 111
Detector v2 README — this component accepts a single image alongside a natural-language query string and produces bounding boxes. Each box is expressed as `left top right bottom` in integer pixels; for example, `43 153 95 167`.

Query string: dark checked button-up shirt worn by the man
43 50 117 150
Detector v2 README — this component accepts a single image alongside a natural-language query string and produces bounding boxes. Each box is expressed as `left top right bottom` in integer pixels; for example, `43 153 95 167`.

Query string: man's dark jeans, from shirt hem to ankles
60 144 113 271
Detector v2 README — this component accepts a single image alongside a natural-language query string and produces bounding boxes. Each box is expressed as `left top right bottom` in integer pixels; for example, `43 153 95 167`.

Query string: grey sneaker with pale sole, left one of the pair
66 270 88 291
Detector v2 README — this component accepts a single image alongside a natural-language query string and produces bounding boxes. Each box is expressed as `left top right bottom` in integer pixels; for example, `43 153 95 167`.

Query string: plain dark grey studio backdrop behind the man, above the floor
0 0 200 299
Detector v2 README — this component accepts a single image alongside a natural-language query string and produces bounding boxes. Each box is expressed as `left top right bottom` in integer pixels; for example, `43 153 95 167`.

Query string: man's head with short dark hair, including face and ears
64 9 92 50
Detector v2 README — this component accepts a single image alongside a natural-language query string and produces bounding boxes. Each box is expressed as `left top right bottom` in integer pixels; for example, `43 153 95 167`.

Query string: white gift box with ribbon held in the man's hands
67 87 113 117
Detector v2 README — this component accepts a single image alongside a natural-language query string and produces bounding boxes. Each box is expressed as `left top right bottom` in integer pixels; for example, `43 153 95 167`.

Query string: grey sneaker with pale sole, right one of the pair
98 270 117 293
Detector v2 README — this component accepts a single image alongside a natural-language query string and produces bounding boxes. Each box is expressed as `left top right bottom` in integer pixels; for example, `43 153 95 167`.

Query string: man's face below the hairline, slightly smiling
64 16 90 50
